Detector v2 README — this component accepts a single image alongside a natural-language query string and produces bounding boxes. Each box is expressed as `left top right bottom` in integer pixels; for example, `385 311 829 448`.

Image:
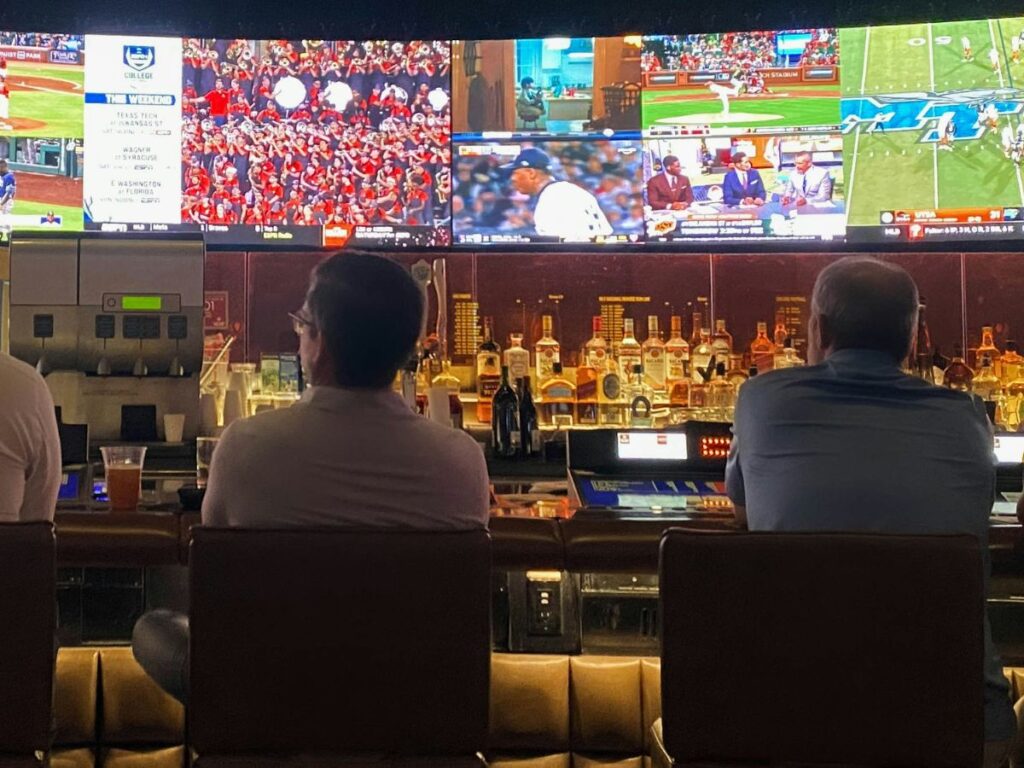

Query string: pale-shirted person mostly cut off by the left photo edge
0 353 60 522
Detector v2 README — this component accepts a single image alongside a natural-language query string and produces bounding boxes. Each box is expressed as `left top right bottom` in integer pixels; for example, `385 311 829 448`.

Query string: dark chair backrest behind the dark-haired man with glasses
189 527 490 756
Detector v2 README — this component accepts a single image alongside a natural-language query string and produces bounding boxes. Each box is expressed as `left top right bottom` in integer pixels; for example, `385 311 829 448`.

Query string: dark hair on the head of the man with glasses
306 251 424 389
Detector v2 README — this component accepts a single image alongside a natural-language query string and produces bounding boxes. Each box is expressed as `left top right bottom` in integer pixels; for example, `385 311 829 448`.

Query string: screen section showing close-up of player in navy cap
452 140 644 245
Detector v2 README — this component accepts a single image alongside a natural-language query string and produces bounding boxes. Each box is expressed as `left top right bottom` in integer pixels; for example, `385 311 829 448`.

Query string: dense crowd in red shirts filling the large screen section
181 39 452 231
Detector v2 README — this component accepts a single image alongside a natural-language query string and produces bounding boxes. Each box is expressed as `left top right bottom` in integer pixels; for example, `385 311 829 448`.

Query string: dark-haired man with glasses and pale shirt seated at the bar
132 252 489 701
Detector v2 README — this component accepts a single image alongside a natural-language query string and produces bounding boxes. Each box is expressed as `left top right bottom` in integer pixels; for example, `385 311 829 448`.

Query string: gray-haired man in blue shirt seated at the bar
726 257 1016 765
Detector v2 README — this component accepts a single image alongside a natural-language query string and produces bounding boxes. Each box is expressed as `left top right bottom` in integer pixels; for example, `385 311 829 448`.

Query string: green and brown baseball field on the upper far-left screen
0 58 85 138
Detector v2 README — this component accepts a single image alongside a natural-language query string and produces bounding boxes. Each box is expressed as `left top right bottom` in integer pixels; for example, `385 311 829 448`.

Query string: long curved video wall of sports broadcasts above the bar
0 16 1024 250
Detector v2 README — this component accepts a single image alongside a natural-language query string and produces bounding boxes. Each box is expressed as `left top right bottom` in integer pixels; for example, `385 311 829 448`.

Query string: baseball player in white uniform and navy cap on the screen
502 147 613 243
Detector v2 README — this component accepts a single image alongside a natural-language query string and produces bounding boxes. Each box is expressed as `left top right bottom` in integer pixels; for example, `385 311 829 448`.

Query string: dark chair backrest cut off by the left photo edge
0 522 56 755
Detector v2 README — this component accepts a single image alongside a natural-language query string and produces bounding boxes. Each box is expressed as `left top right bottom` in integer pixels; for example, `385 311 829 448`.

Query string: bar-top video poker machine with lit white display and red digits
567 421 732 520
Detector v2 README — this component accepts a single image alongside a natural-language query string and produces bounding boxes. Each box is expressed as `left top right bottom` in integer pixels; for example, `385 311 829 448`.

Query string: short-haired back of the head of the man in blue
811 256 920 362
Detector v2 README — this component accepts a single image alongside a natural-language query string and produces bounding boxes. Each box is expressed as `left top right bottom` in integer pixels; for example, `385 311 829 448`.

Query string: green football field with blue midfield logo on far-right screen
840 17 1024 226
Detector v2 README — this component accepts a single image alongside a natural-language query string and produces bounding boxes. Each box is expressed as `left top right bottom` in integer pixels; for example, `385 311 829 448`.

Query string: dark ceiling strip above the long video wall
0 0 1021 39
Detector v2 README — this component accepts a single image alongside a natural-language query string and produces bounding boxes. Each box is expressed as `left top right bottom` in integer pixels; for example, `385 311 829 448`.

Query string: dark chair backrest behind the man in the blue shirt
660 528 984 768
